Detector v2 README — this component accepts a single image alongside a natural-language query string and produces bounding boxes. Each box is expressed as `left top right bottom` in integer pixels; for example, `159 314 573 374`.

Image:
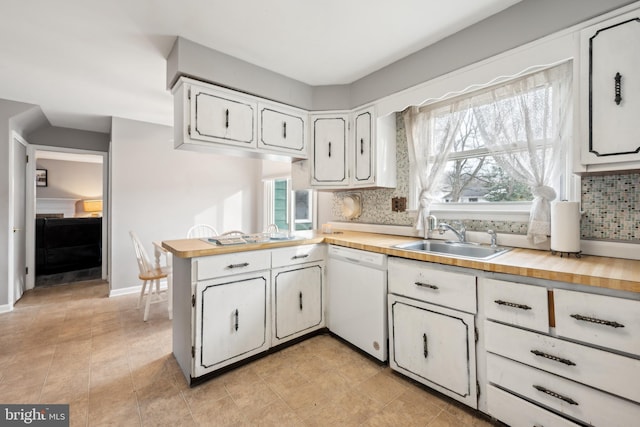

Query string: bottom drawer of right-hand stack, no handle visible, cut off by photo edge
487 385 579 427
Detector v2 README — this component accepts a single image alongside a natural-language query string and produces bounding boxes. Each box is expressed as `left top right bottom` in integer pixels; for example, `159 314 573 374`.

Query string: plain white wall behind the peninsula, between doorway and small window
109 118 262 293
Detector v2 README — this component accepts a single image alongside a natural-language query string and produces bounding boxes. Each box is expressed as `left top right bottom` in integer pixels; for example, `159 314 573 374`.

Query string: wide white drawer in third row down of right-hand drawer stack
487 353 640 427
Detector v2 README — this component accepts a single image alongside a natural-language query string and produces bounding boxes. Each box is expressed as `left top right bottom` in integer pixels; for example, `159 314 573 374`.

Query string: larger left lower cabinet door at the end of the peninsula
194 274 269 376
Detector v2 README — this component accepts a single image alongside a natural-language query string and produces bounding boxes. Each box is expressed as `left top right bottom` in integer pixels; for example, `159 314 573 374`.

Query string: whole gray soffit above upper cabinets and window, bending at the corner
167 0 634 110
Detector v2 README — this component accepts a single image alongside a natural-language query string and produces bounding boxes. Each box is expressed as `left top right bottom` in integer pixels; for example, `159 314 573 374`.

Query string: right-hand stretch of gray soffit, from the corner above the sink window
351 0 635 106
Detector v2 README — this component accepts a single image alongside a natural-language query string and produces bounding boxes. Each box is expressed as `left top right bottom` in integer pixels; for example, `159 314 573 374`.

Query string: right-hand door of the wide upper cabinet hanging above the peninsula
258 103 307 158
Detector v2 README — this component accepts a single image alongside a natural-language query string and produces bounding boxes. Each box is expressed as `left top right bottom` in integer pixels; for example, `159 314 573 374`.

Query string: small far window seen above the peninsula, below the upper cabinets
264 179 313 231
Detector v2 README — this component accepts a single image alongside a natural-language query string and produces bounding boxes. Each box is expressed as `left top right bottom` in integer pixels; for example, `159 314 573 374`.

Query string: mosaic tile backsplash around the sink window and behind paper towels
332 113 640 244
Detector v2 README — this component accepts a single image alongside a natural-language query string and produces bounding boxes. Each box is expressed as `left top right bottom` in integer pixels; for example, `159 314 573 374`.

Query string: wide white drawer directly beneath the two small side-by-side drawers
485 321 640 402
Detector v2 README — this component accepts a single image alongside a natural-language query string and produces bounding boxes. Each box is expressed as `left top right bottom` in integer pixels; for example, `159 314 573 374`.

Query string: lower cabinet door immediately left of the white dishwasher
273 265 324 343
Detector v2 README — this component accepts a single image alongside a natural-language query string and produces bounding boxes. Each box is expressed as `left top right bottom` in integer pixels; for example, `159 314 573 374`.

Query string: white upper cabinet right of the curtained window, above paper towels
580 12 640 172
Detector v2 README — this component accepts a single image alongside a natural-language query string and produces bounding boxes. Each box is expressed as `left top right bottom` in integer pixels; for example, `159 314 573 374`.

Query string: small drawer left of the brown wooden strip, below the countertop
480 279 549 332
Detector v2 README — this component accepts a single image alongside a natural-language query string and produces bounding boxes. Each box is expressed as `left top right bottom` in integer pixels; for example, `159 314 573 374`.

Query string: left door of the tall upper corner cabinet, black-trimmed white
311 114 349 186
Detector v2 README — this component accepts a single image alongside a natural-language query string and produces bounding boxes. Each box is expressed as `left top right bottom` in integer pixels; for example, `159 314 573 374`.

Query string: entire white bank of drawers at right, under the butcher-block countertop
478 278 640 427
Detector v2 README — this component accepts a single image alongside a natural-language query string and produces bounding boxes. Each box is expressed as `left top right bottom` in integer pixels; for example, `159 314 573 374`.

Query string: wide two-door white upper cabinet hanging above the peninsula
173 77 307 159
